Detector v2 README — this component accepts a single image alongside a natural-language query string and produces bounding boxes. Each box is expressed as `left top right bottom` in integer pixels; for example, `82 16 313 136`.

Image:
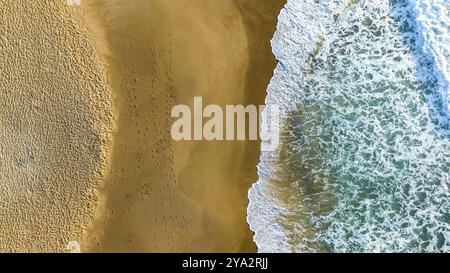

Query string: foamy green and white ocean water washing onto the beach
247 0 450 252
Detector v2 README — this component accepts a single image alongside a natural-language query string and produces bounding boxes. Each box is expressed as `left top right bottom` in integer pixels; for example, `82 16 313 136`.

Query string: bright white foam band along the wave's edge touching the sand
247 0 351 252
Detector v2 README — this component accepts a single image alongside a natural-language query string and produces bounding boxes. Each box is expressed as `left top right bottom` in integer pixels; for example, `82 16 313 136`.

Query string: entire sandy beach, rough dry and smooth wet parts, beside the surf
0 0 285 252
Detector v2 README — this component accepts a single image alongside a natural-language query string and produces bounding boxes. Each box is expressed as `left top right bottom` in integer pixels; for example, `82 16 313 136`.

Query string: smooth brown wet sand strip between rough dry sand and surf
81 0 285 252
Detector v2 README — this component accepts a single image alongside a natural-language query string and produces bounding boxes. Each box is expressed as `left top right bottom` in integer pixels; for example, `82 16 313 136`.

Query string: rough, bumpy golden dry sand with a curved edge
0 0 112 252
